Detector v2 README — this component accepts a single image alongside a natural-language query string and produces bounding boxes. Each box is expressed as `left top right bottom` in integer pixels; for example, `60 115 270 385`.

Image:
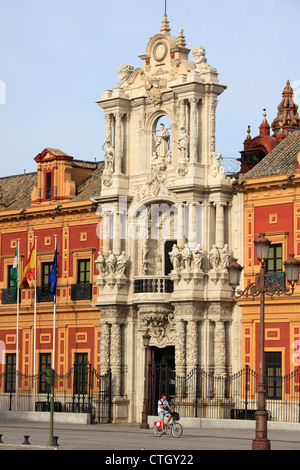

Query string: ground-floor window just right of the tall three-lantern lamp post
265 352 282 400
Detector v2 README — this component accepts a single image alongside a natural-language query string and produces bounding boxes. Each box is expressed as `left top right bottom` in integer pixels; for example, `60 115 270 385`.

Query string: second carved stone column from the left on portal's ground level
110 323 122 396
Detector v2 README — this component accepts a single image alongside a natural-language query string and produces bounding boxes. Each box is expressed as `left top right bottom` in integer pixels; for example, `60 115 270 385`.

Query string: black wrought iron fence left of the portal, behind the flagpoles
0 363 112 424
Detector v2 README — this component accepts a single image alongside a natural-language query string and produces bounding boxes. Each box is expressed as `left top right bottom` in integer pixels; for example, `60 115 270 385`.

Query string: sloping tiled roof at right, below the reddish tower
243 129 300 180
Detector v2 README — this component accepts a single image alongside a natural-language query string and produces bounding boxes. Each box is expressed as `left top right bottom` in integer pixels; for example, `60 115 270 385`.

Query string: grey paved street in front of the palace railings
0 420 300 456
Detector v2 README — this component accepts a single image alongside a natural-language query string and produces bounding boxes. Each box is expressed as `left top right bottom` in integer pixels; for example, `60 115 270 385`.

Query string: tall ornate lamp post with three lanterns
227 233 300 450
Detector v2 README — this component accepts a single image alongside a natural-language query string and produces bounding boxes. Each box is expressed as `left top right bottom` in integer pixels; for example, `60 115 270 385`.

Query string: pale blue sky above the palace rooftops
0 0 300 177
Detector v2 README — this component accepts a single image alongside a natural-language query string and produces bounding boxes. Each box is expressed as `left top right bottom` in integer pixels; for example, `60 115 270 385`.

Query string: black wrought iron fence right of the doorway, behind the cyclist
148 361 300 422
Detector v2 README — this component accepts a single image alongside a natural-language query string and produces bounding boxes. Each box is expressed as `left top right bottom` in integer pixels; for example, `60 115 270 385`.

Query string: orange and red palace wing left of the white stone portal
0 148 103 380
